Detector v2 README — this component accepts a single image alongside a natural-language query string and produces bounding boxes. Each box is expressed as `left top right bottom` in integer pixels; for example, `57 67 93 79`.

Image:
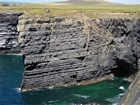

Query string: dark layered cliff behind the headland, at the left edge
0 13 22 54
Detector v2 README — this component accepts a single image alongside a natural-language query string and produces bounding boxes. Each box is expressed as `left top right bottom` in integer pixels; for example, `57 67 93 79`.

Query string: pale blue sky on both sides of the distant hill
0 0 140 4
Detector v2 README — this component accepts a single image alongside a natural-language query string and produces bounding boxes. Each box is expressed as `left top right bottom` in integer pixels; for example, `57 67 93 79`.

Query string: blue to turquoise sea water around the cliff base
0 55 130 105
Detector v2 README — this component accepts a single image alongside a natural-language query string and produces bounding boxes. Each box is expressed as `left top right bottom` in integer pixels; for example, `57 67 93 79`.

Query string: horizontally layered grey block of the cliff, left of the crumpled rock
18 17 112 90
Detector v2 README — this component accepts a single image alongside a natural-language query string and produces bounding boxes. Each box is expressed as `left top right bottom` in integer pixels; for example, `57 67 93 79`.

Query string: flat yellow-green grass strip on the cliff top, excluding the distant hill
0 0 140 17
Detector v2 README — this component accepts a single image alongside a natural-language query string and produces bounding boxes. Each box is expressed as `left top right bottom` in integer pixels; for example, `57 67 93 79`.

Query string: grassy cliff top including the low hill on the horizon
0 0 140 18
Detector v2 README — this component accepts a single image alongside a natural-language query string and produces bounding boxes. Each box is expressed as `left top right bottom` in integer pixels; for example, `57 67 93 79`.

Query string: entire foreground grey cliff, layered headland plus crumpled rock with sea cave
18 17 140 90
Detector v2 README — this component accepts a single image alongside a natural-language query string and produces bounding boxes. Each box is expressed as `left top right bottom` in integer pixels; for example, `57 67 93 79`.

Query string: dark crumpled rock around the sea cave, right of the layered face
100 19 140 76
